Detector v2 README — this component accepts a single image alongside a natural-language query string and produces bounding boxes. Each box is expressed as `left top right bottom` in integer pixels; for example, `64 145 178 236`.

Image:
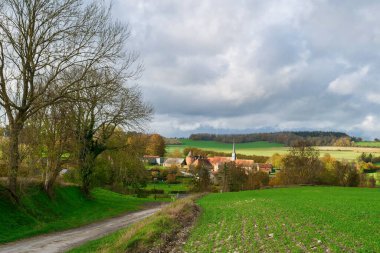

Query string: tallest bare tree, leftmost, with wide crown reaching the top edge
0 0 135 198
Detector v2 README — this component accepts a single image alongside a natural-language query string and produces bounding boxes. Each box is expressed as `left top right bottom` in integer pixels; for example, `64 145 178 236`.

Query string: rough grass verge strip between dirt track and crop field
69 196 199 253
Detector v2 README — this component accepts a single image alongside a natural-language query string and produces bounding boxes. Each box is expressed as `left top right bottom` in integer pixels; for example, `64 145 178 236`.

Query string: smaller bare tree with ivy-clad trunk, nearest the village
71 71 152 195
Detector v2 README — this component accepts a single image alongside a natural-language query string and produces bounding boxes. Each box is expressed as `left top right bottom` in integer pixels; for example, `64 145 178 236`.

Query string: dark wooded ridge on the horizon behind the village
189 131 358 146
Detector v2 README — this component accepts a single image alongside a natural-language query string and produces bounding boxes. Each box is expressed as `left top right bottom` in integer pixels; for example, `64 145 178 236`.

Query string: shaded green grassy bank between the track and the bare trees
0 186 156 243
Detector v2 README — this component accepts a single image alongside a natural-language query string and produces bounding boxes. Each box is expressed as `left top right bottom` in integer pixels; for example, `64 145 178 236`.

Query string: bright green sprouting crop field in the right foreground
184 187 380 252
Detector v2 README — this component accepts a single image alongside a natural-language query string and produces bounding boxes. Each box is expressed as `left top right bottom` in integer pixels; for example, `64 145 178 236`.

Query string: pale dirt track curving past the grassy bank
0 207 161 253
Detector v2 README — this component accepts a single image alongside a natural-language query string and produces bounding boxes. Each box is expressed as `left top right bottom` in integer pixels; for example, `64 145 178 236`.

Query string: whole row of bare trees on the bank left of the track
0 0 152 199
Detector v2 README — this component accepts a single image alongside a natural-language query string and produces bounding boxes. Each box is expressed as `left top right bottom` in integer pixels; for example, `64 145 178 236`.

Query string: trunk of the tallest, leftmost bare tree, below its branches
8 125 22 200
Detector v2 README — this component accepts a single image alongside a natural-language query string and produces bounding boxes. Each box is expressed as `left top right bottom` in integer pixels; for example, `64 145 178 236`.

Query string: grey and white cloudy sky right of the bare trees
113 0 380 138
